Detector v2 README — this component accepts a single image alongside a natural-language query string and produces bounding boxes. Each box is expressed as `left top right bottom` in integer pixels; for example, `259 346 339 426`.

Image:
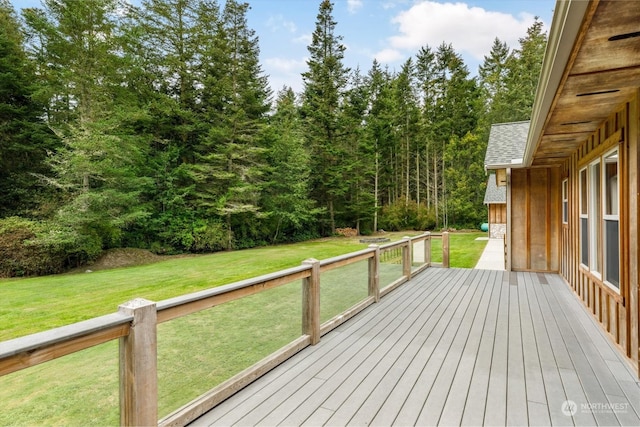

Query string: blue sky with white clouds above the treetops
11 0 555 92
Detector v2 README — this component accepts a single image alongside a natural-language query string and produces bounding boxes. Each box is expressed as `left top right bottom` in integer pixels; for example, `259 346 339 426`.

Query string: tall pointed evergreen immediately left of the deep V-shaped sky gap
198 0 270 249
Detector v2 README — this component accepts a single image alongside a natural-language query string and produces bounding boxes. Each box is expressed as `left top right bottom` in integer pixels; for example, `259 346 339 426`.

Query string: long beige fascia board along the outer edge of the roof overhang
523 0 590 167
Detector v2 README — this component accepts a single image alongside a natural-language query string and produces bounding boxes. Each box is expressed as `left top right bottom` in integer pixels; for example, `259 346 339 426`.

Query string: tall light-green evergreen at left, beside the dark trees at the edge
25 0 146 246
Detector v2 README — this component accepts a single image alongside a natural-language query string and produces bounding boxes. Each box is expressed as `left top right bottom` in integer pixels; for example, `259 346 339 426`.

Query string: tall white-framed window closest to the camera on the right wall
602 149 620 290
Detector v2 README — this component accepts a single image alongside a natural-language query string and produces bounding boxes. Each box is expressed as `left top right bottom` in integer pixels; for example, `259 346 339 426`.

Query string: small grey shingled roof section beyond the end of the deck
484 120 529 169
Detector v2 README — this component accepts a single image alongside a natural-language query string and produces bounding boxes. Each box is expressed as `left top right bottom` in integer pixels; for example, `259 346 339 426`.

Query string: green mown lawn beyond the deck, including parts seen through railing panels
0 233 485 426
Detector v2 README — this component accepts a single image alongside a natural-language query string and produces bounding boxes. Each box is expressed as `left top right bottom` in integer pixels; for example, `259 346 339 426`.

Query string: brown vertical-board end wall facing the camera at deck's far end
511 168 562 272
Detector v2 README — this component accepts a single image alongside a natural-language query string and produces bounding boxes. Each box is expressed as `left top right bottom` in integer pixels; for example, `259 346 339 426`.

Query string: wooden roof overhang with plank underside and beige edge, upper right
523 0 640 167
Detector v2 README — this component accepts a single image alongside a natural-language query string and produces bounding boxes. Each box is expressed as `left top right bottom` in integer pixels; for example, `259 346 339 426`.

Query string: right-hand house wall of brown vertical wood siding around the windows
554 98 640 369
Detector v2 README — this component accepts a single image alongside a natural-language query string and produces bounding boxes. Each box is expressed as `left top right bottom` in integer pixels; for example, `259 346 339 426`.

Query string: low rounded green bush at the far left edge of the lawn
0 217 102 277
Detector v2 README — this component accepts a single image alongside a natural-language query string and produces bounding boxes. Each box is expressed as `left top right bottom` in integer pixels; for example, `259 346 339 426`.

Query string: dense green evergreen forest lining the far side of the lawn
0 0 546 275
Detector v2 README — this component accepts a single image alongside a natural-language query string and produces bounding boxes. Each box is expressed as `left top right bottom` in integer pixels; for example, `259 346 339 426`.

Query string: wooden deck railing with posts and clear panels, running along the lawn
0 232 449 426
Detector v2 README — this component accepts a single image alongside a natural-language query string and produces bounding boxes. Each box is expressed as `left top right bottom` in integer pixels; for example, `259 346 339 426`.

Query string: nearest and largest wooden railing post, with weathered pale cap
118 298 158 426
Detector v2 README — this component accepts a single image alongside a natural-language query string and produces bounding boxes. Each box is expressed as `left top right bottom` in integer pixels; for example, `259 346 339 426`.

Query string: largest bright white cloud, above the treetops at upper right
376 0 534 61
